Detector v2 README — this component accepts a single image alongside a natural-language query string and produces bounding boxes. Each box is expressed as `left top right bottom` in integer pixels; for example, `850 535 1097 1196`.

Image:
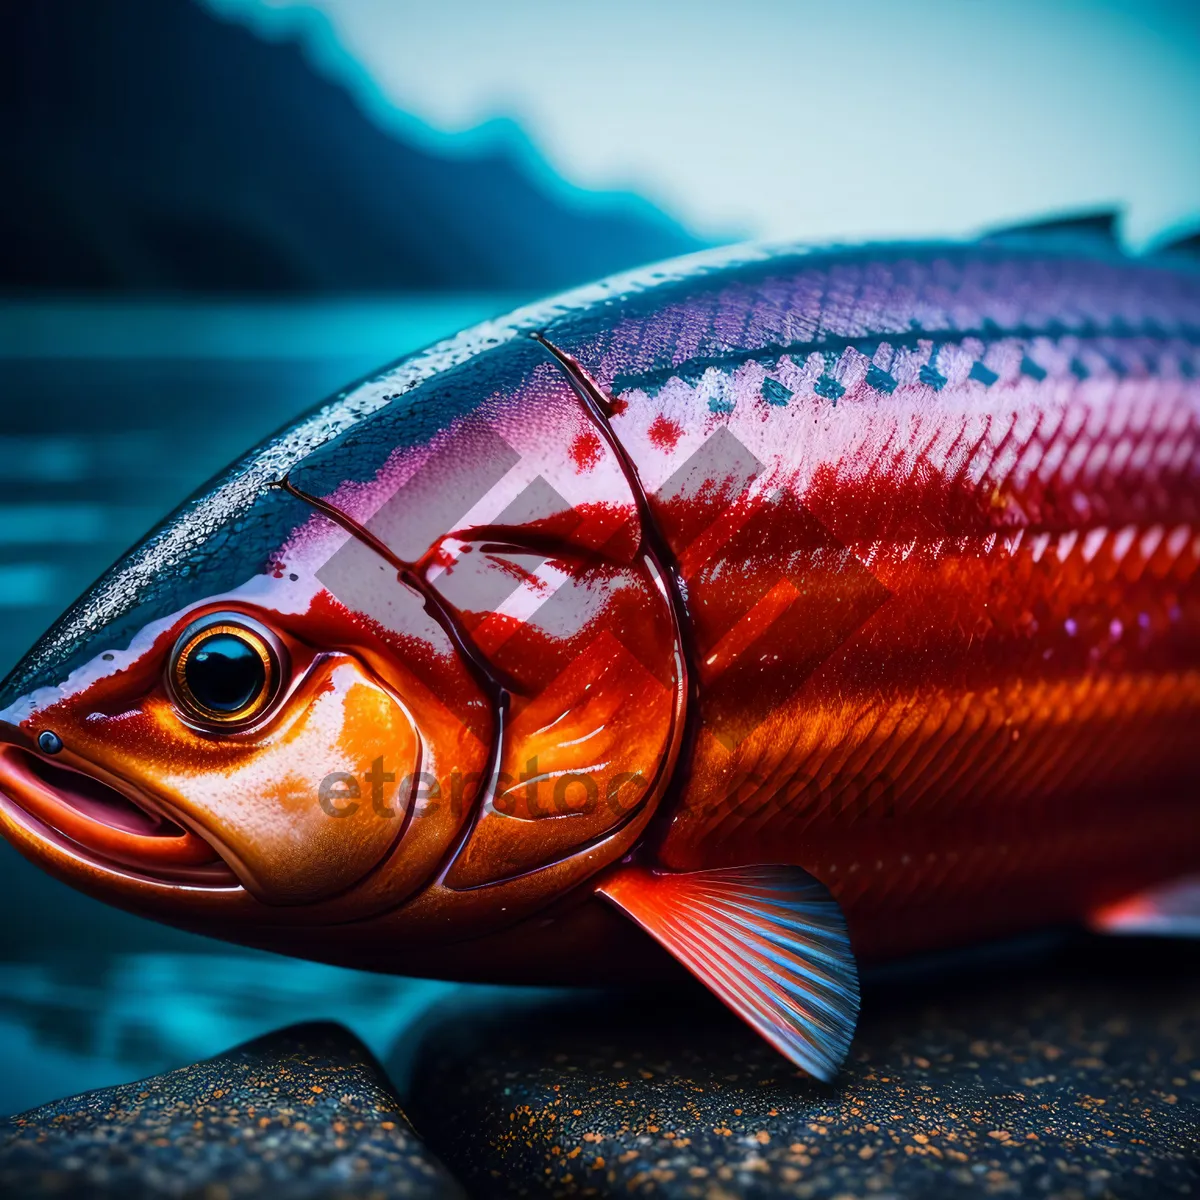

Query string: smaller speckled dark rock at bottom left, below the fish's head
0 1024 462 1200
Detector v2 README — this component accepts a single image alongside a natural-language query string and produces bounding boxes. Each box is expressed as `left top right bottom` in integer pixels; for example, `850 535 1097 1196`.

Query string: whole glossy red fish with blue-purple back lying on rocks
0 217 1200 1080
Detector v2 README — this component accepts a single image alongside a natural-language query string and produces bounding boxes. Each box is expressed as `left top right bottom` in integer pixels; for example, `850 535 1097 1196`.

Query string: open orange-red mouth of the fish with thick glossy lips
0 744 239 888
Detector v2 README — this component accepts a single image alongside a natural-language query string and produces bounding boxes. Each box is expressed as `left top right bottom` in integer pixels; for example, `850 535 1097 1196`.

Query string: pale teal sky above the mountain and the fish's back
208 0 1200 245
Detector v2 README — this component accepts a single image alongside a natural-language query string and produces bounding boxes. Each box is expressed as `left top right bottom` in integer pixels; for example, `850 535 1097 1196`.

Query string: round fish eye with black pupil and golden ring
167 612 284 728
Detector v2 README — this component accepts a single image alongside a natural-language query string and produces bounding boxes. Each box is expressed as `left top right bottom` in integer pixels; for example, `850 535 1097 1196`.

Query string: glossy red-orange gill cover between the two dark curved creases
288 340 685 892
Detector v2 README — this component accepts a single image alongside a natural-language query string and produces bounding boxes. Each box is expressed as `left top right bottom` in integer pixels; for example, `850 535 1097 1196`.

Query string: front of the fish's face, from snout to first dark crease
0 475 486 930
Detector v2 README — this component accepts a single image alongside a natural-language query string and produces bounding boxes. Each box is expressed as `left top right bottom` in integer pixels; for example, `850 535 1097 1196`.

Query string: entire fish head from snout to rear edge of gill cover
0 342 685 970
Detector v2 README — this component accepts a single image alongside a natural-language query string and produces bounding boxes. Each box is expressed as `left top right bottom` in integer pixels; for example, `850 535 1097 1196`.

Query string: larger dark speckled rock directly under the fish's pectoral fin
412 943 1200 1200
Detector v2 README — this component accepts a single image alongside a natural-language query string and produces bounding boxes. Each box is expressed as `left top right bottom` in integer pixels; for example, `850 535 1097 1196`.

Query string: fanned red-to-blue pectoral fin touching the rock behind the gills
596 865 858 1080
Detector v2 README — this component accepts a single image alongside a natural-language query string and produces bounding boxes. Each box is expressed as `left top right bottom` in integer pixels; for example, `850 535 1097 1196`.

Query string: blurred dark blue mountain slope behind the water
0 0 697 293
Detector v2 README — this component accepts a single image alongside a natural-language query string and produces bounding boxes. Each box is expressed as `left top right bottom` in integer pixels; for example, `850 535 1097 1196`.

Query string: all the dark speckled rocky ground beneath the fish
0 941 1200 1200
